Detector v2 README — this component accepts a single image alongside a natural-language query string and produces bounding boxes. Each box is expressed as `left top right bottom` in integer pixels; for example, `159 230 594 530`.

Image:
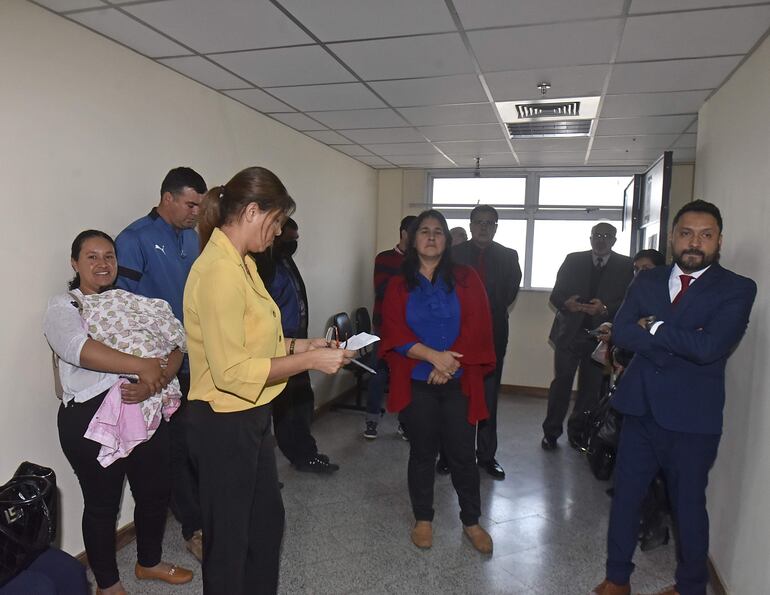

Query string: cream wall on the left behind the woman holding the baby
0 0 377 553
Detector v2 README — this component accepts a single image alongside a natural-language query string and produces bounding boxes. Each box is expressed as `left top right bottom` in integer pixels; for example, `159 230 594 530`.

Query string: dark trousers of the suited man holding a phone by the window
543 330 603 442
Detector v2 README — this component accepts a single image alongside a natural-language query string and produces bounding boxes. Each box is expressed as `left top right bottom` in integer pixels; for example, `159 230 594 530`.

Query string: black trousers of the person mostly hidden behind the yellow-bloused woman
272 372 318 464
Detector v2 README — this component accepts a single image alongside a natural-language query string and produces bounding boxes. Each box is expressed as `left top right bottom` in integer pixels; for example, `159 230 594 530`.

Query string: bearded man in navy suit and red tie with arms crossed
593 200 757 595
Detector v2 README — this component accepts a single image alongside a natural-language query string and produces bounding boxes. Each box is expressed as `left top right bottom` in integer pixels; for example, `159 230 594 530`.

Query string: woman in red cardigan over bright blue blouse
380 210 495 554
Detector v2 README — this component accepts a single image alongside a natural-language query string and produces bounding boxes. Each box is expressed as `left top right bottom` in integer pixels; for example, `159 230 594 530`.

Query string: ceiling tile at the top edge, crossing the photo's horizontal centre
281 0 455 41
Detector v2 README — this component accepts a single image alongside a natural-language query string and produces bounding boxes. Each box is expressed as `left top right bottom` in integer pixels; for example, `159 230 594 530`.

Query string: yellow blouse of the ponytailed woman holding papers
184 228 286 413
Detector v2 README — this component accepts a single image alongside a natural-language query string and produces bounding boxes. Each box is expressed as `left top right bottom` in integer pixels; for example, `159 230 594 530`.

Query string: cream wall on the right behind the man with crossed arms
695 31 770 595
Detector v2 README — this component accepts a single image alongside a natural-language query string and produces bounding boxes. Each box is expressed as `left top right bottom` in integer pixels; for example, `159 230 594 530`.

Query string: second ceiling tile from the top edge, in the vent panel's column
468 19 619 72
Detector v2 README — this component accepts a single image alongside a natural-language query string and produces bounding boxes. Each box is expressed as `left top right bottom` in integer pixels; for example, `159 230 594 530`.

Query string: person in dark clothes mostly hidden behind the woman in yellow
253 219 339 473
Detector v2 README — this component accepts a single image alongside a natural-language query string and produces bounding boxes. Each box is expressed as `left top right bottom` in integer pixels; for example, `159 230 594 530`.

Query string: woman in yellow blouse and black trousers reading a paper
184 167 355 595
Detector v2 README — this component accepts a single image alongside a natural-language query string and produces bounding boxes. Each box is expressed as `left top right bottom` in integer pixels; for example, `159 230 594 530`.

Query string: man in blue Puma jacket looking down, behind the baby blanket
115 167 206 560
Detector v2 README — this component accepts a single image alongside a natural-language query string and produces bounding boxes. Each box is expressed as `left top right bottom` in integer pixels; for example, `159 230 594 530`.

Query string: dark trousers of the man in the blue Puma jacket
169 372 202 540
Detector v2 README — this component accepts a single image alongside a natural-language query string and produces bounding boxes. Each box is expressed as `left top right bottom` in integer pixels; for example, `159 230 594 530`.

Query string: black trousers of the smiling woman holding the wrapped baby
58 393 171 588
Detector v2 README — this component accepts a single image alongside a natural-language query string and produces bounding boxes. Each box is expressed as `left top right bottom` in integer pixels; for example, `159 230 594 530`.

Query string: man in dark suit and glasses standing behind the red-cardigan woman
452 205 521 479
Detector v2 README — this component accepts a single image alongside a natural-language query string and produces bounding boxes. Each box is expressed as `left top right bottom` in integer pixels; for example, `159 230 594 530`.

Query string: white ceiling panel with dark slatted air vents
495 97 599 139
